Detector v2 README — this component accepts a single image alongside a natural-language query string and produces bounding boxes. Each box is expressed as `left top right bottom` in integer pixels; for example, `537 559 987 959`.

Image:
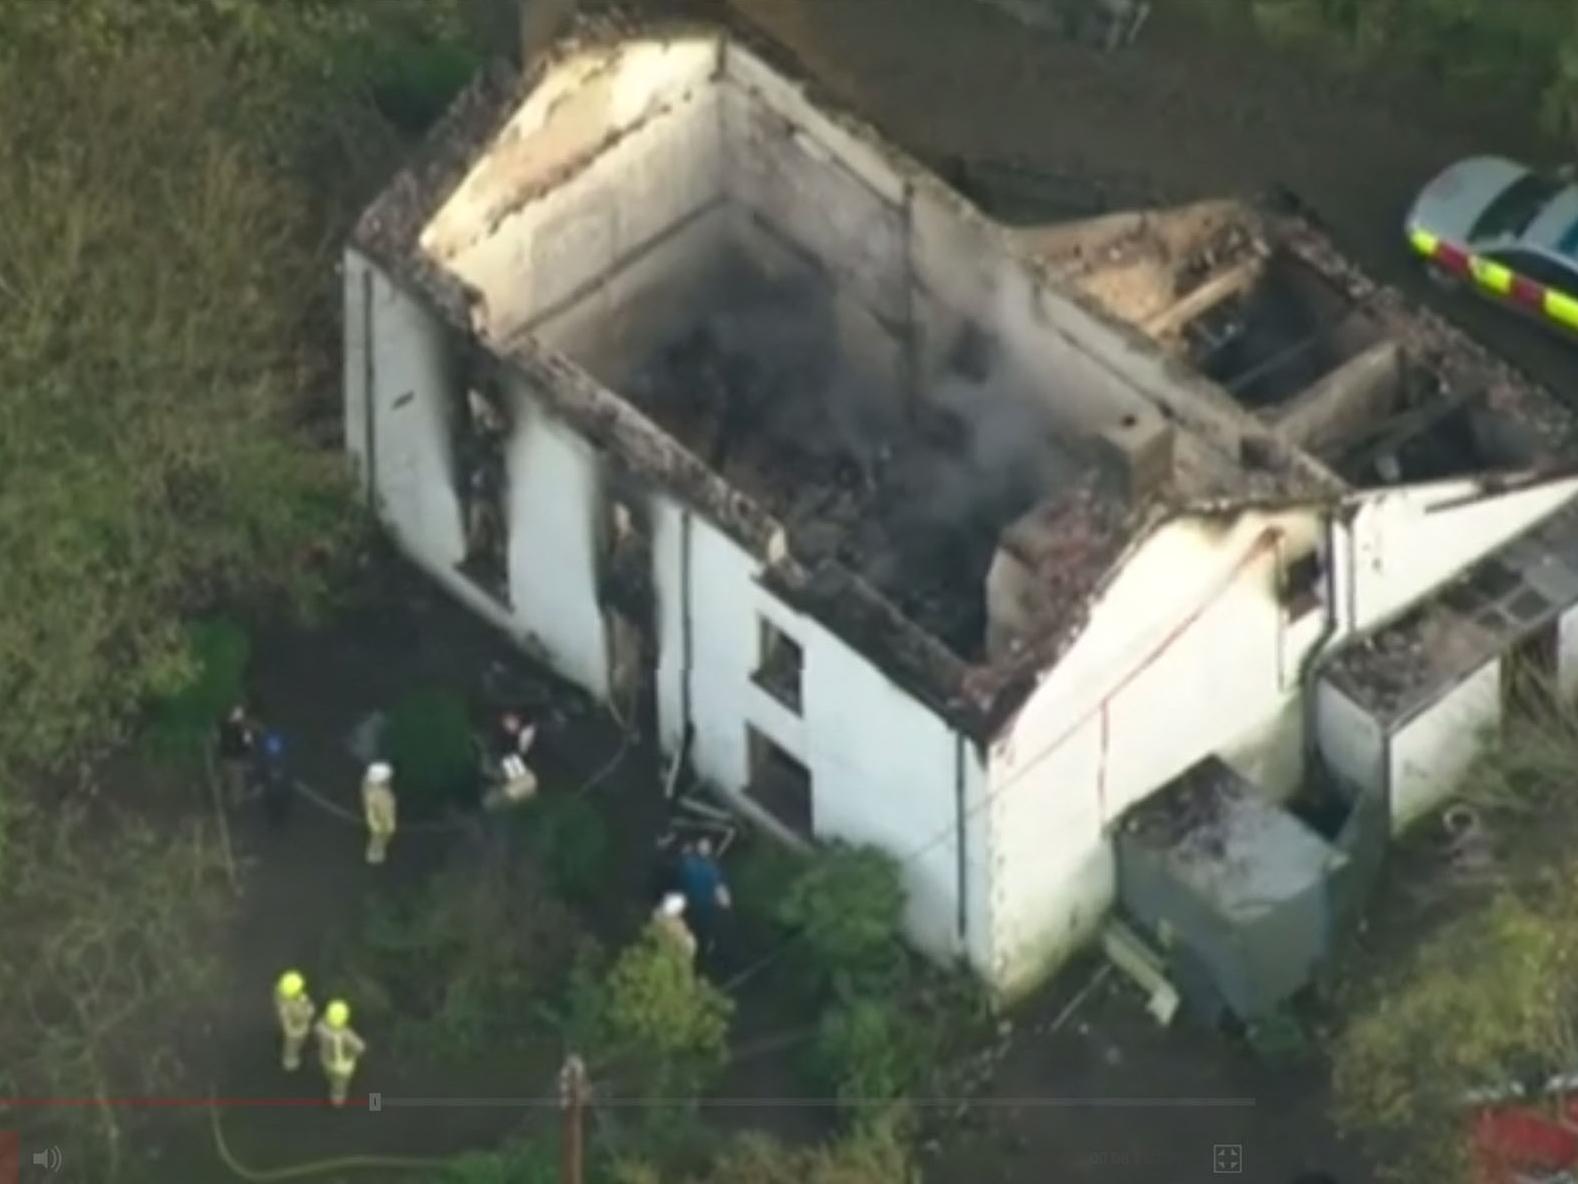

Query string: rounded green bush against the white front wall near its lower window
776 843 907 998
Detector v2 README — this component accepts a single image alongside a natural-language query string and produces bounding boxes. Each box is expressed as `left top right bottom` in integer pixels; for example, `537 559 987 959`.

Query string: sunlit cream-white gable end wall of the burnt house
989 511 1322 995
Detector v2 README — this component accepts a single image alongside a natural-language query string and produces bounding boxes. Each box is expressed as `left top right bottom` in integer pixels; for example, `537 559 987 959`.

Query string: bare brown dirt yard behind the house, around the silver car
726 0 1578 398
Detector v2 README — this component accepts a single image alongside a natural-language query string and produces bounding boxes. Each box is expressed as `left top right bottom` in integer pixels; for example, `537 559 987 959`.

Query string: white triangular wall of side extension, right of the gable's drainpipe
1348 477 1578 630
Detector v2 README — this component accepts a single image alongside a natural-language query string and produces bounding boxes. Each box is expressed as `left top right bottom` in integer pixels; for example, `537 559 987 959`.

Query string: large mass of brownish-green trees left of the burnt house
0 0 511 798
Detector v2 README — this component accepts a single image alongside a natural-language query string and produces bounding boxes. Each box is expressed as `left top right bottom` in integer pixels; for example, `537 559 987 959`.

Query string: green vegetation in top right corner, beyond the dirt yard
1209 0 1578 137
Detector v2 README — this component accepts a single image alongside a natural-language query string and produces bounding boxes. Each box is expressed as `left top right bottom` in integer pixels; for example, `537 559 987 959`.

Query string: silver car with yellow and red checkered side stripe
1406 156 1578 335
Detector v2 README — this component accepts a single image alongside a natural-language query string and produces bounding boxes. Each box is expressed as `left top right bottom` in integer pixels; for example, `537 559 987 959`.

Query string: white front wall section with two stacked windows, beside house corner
653 497 986 966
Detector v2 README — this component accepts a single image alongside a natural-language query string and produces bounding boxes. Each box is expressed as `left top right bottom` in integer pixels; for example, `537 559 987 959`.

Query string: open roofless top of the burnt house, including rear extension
353 18 1572 739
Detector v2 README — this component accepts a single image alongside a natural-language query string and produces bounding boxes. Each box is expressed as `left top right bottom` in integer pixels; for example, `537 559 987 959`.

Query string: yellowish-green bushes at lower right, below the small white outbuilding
1333 681 1578 1182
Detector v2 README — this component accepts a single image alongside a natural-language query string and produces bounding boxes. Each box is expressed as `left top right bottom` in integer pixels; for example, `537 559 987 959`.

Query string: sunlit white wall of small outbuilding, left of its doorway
1390 660 1502 834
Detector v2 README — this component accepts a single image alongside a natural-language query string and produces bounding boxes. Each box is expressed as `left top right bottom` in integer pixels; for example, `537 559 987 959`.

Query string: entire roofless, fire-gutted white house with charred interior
344 28 1578 995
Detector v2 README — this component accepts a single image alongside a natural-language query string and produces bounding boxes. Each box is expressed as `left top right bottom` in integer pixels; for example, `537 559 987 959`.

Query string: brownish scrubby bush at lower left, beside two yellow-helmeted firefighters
0 804 229 1184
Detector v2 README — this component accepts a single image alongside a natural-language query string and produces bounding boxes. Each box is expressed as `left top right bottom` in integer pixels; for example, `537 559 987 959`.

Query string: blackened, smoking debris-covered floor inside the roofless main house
537 222 1064 660
